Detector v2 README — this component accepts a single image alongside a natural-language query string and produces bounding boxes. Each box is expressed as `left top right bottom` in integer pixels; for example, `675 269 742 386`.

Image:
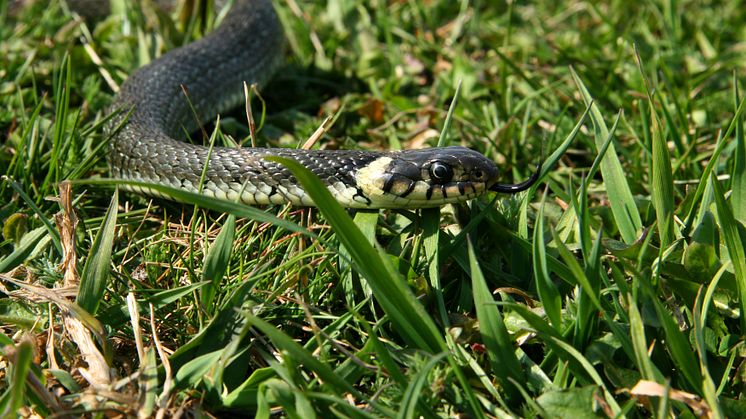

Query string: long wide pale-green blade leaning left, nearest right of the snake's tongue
570 68 642 244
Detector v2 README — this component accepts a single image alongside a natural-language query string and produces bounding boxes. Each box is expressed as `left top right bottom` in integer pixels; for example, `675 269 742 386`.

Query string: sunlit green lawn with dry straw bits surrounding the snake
0 0 746 418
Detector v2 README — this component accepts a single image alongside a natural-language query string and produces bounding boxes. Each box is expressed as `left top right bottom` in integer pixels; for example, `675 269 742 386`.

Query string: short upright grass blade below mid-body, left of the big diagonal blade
201 214 236 312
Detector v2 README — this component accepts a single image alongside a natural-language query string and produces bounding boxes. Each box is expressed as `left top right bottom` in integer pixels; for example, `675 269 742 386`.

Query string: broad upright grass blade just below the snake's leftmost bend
75 191 119 314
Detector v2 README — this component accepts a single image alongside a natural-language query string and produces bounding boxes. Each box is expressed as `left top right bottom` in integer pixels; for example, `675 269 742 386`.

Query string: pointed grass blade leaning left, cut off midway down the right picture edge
710 173 746 330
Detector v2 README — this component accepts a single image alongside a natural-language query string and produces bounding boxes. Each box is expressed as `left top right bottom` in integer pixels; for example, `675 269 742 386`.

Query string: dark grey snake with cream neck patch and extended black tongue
106 0 539 209
